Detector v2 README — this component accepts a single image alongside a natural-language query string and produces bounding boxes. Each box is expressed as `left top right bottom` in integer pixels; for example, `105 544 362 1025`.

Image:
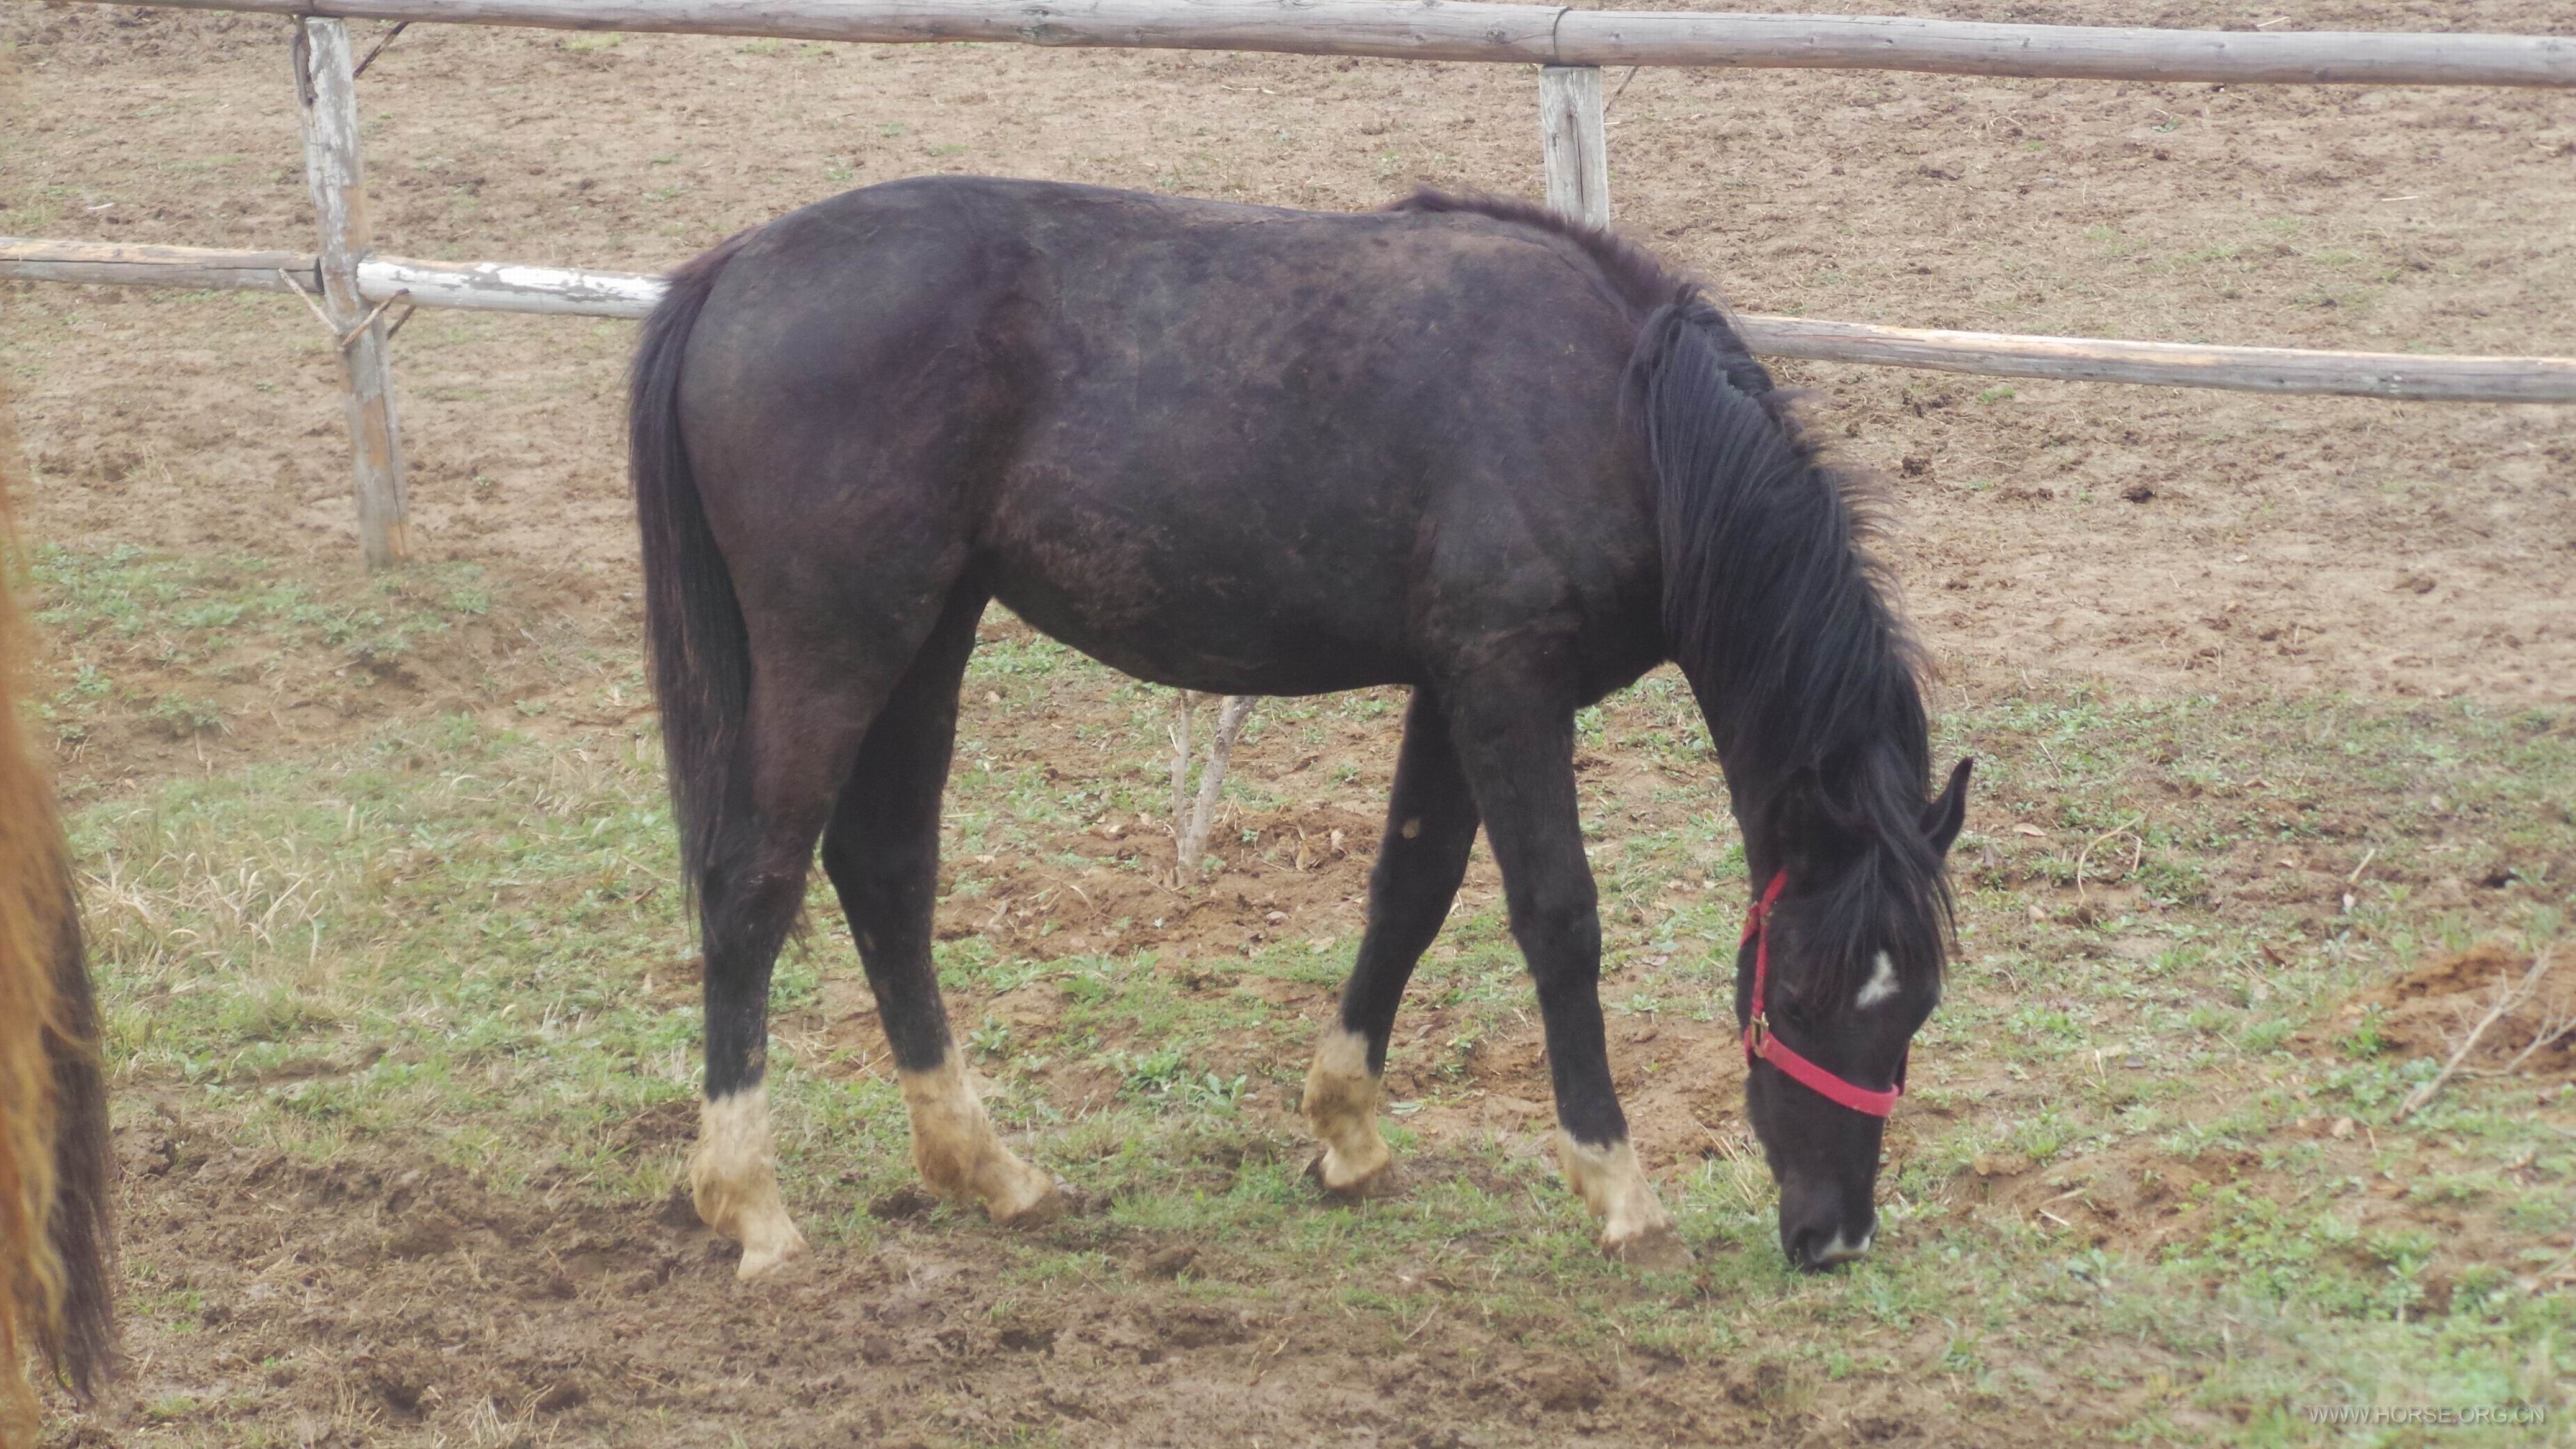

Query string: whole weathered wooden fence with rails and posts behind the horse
0 0 2576 566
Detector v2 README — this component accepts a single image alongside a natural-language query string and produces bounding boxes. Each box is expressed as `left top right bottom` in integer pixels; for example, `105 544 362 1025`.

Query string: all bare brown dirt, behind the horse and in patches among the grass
0 0 2576 1444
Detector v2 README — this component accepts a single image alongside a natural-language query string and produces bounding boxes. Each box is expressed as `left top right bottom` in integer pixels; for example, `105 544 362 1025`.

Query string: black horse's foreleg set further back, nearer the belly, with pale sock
1303 690 1476 1194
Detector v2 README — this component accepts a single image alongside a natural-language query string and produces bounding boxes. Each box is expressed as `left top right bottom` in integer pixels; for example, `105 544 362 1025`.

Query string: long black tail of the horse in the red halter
626 232 752 898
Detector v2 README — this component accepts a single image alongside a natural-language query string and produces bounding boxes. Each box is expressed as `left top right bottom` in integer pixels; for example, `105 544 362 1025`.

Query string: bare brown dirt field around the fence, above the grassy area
7 2 2576 744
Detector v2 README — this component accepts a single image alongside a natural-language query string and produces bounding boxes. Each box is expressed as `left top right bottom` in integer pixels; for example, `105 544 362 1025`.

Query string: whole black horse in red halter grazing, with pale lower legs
631 178 1965 1276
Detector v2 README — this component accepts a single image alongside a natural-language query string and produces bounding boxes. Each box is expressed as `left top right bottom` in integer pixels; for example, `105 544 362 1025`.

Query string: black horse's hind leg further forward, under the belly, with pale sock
822 587 1062 1222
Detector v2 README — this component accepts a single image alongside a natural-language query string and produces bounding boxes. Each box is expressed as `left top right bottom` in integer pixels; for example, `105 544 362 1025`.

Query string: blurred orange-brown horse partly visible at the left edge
0 468 116 1444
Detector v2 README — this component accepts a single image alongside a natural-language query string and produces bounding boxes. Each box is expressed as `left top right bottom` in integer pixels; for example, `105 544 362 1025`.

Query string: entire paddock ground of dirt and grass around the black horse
0 0 2576 1444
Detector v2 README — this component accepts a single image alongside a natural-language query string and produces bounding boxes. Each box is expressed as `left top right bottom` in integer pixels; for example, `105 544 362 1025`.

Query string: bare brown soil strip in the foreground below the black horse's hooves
121 1104 1937 1447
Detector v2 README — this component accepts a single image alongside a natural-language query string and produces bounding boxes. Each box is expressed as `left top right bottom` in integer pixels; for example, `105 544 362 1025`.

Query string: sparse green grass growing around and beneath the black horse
55 584 2576 1444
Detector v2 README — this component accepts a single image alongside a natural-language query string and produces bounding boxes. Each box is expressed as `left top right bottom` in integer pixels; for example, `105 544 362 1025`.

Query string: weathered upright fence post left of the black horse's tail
294 16 412 569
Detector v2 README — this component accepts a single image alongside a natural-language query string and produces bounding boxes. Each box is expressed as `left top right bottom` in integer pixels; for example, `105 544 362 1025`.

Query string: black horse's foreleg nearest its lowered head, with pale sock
1450 693 1690 1266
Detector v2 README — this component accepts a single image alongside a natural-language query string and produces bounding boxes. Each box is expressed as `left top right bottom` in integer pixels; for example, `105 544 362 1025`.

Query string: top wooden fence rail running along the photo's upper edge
70 0 2576 85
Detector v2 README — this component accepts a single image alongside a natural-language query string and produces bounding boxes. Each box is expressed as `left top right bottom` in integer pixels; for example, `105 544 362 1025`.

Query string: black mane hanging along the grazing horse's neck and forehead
1391 191 1950 1001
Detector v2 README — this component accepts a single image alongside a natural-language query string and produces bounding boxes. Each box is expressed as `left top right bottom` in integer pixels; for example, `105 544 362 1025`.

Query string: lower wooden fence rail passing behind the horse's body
0 237 2576 401
